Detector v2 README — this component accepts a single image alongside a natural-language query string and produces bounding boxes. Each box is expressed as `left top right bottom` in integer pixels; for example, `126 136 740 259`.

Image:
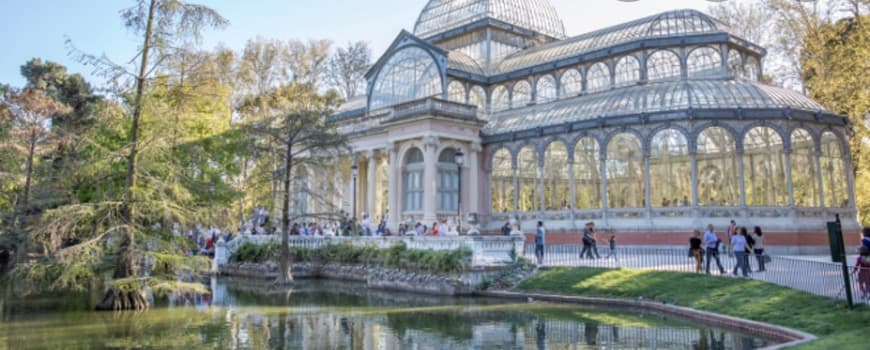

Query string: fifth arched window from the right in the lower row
649 129 692 207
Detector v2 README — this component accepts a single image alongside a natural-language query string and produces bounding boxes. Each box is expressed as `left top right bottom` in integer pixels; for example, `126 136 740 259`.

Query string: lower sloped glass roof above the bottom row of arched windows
483 80 825 135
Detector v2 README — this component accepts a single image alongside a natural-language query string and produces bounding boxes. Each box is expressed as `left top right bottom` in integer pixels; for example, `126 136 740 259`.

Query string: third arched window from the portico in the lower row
544 141 571 210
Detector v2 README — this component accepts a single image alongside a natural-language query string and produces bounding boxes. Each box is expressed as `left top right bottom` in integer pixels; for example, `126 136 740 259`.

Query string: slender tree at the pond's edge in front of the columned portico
244 83 346 284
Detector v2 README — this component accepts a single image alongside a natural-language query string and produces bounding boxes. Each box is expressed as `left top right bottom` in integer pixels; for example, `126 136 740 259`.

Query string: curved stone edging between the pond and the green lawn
474 291 818 349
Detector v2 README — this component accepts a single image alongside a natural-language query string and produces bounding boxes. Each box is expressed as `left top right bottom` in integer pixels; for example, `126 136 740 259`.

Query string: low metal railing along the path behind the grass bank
523 244 870 304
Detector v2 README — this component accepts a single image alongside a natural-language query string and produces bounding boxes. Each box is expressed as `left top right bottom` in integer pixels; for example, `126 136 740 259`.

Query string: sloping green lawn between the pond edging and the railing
516 267 870 349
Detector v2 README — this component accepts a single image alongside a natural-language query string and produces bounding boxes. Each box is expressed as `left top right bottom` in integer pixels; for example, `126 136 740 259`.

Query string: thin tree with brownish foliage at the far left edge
3 88 70 262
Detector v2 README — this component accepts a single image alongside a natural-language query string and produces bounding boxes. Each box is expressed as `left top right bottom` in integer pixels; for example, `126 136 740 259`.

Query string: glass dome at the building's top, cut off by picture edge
414 0 565 39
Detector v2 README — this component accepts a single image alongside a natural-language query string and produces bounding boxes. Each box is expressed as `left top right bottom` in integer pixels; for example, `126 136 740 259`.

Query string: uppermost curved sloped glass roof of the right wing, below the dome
496 10 729 73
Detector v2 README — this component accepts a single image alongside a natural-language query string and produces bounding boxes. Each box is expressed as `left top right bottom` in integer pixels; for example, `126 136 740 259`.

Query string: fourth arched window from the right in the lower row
696 127 740 206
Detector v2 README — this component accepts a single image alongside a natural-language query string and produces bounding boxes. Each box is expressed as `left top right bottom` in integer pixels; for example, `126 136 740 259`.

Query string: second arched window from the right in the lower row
791 129 821 207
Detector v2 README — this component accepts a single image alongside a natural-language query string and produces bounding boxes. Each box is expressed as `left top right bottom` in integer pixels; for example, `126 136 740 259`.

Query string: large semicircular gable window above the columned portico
371 47 443 109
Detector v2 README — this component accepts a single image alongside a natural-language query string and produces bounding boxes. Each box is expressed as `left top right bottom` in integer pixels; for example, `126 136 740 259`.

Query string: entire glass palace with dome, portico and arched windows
322 0 859 251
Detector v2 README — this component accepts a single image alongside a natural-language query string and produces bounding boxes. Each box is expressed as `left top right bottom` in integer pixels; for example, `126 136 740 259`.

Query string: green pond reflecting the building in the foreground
0 280 772 350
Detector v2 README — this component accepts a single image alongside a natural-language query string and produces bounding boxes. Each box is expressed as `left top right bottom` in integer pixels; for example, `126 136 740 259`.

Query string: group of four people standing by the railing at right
689 220 770 277
